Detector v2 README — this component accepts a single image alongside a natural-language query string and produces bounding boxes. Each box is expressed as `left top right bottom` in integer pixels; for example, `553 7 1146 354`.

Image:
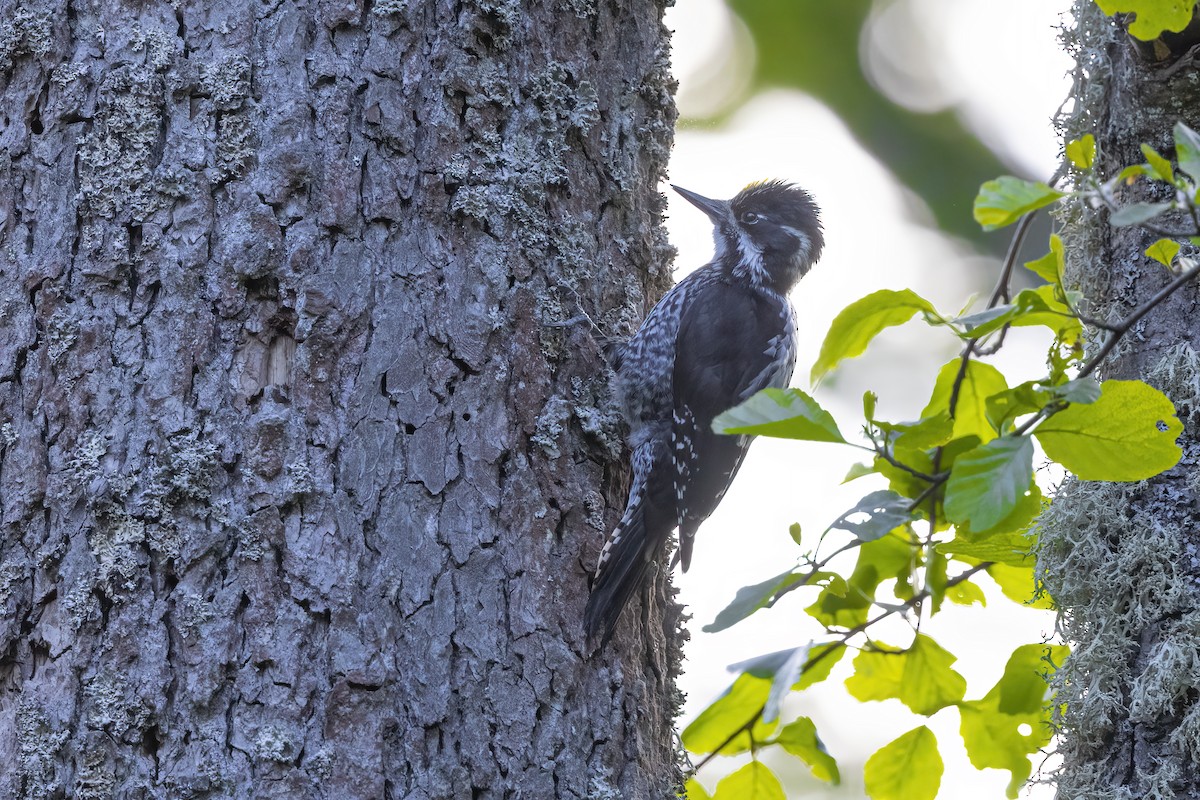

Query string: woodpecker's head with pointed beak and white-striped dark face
672 180 824 294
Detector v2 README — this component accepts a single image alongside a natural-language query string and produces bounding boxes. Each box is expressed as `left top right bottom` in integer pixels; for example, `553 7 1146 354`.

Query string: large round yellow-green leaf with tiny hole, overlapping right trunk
1033 380 1183 481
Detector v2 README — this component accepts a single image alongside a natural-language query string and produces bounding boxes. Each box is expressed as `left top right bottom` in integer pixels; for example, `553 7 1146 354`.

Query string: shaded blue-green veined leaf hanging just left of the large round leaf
944 437 1033 530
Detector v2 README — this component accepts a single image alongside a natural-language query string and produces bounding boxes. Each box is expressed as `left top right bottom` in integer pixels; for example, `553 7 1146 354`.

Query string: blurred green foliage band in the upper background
678 0 1057 252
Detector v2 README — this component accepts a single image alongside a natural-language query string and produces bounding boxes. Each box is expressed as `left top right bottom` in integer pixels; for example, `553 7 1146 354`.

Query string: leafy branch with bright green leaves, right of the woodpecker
683 125 1200 800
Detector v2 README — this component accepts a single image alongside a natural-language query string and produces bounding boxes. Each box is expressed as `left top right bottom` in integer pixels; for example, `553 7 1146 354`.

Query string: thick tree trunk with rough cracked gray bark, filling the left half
0 0 678 799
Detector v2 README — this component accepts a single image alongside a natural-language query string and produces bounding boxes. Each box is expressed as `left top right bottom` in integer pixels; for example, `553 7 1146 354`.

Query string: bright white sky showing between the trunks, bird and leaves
667 0 1070 800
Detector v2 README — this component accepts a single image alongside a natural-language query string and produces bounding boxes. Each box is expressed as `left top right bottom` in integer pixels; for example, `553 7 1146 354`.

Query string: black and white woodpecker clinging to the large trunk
584 181 824 642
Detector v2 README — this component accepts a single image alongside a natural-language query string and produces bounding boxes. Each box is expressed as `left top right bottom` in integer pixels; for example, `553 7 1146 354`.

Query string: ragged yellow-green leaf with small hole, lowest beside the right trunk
959 644 1067 798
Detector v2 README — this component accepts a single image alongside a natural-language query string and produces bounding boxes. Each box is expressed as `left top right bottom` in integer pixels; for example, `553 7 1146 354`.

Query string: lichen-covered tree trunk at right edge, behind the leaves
1039 0 1200 800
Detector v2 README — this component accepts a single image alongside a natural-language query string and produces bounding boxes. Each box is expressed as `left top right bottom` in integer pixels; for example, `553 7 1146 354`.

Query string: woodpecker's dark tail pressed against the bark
583 503 658 648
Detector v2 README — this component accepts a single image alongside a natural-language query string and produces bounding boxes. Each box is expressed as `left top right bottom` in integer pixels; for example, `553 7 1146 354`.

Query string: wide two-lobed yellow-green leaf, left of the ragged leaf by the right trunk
846 633 967 716
